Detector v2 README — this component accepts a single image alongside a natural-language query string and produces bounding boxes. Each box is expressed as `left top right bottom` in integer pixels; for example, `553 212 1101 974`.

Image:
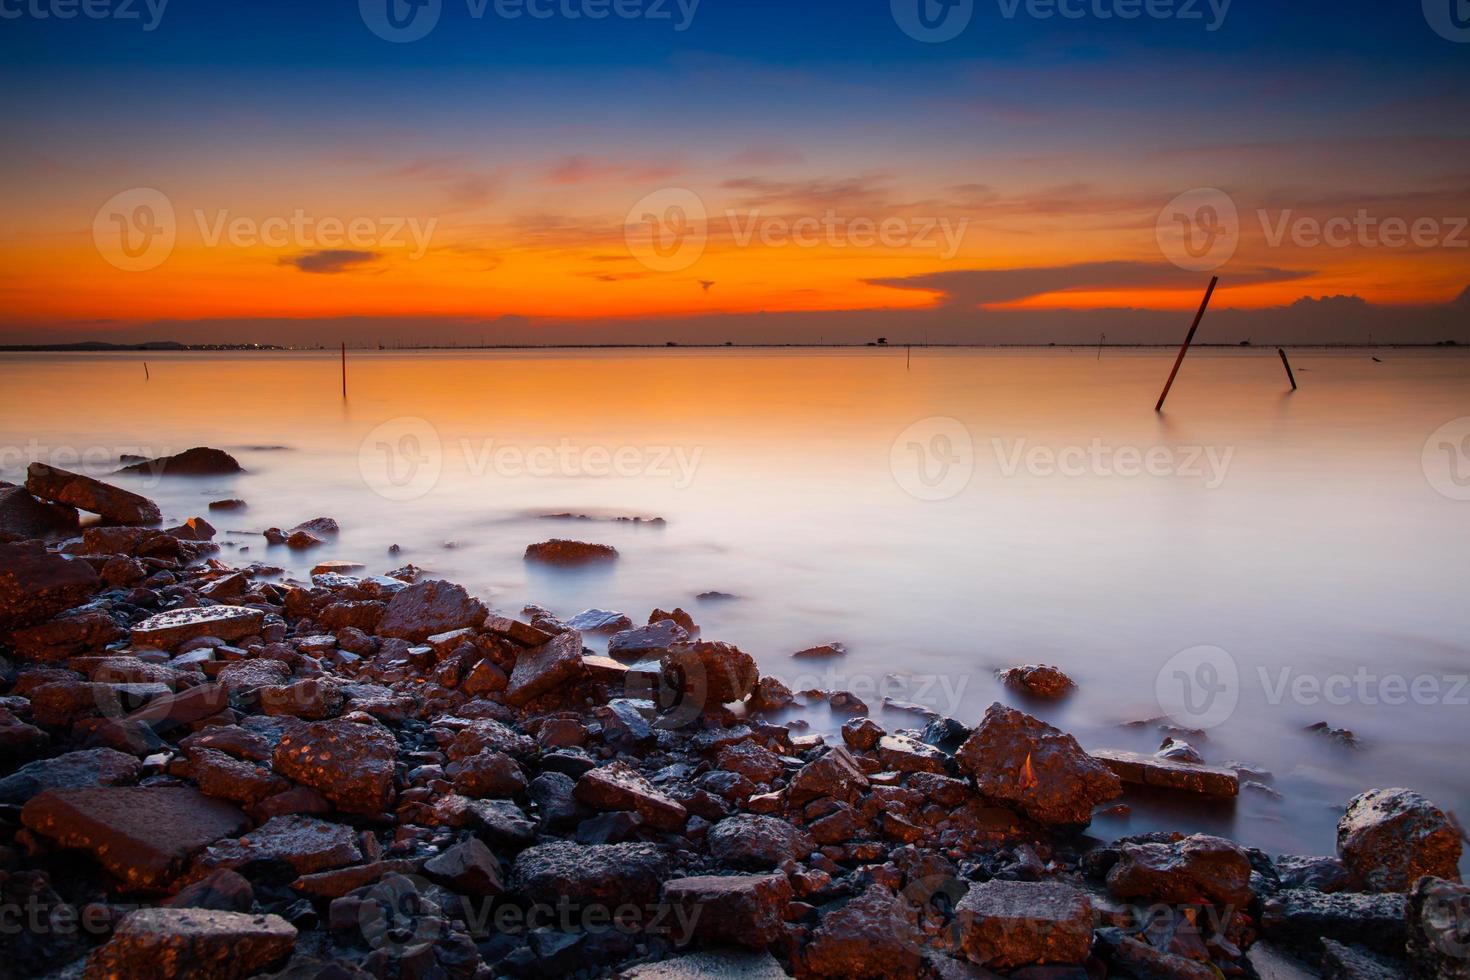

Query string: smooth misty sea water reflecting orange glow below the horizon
0 348 1470 854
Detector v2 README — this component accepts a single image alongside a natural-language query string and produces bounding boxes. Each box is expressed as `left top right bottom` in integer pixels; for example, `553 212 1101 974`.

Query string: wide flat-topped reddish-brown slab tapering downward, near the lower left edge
21 786 248 890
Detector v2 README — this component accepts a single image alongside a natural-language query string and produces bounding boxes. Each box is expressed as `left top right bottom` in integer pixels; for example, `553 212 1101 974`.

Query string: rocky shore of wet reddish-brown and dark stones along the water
0 455 1470 980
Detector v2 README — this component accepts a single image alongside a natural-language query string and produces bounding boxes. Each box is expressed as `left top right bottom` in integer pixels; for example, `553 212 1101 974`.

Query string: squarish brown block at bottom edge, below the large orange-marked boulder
954 882 1092 970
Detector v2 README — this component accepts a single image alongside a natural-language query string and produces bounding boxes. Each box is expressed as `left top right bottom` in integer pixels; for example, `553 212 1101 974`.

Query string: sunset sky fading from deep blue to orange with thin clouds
0 0 1470 344
